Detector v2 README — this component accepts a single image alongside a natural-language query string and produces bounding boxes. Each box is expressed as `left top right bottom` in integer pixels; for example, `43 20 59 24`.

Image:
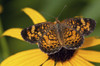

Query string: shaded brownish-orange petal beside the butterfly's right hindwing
80 37 100 48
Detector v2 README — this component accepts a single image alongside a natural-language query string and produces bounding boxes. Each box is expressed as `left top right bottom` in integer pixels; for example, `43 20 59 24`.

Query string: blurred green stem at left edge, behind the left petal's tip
0 17 9 59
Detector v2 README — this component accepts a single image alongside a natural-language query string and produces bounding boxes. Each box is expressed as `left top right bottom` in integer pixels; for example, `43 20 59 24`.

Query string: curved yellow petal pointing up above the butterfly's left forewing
22 8 46 24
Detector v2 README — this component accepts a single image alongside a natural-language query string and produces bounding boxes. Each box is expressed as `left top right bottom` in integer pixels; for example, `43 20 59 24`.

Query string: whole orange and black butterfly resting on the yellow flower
21 18 96 54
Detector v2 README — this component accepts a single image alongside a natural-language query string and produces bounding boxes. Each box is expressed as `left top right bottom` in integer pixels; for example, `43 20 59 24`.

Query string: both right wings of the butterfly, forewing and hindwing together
61 18 96 49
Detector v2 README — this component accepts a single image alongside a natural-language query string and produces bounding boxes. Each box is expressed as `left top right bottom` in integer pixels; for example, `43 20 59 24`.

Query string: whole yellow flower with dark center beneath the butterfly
1 8 100 66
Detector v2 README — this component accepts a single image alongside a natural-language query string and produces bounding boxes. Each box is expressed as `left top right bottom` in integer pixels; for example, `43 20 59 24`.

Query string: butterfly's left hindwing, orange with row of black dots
39 27 62 54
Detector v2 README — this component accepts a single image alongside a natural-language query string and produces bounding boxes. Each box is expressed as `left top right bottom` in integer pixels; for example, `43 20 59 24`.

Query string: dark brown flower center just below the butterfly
48 48 76 62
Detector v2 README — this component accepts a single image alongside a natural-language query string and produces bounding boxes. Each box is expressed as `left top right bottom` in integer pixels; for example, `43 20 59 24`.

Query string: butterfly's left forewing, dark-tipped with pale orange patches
21 22 52 43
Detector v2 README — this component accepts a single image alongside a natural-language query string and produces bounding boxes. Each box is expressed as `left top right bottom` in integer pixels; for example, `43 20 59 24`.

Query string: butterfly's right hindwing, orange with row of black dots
63 26 84 49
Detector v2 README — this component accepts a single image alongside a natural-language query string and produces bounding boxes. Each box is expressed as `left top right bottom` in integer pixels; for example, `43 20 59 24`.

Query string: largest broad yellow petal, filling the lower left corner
1 49 48 66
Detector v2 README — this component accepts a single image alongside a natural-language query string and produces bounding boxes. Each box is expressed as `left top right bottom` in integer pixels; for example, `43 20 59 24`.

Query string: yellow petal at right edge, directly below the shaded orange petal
77 50 100 63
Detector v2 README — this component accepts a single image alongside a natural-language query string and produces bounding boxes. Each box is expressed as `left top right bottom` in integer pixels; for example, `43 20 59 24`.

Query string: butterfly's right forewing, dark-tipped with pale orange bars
62 18 96 35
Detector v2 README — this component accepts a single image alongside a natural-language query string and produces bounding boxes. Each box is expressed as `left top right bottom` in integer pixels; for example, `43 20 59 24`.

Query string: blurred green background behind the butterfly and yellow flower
0 0 100 66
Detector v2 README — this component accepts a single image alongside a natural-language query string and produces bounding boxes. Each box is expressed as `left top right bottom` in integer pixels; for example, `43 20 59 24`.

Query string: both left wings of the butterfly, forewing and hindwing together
21 22 61 54
